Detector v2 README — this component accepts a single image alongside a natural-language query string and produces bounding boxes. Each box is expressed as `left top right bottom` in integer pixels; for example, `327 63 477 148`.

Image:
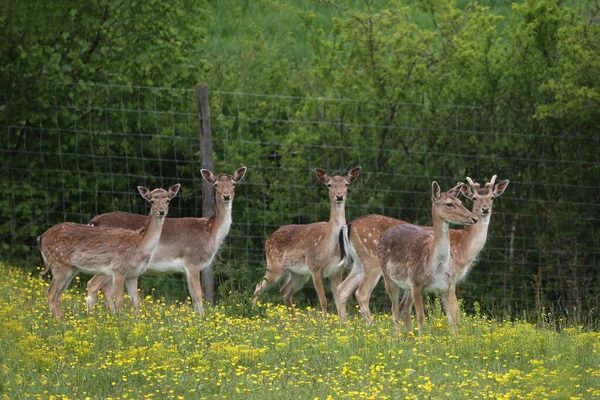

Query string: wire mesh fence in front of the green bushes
0 84 600 317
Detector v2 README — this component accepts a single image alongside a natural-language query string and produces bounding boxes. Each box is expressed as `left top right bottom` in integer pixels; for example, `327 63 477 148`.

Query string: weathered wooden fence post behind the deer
196 83 215 305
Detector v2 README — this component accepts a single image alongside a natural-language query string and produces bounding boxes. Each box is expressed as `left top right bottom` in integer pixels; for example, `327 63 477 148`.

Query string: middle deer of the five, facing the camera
252 167 360 318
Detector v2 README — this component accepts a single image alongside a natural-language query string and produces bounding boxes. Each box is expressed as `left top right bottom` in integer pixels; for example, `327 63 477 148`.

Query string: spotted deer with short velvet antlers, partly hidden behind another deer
338 175 509 325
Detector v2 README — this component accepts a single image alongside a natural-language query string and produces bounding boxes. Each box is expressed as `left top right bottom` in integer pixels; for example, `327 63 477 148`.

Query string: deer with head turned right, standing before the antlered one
378 182 477 337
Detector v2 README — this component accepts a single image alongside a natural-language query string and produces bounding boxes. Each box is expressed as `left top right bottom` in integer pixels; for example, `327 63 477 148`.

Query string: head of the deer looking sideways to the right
431 181 477 225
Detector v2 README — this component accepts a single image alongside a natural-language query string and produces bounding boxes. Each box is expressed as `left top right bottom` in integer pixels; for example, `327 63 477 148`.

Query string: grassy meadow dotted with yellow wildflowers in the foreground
0 265 600 399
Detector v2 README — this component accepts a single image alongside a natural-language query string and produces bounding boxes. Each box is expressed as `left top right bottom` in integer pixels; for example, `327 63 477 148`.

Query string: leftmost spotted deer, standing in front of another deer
37 184 181 319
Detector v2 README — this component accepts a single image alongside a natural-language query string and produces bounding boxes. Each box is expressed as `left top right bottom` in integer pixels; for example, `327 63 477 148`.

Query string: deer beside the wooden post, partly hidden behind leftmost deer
88 167 246 314
